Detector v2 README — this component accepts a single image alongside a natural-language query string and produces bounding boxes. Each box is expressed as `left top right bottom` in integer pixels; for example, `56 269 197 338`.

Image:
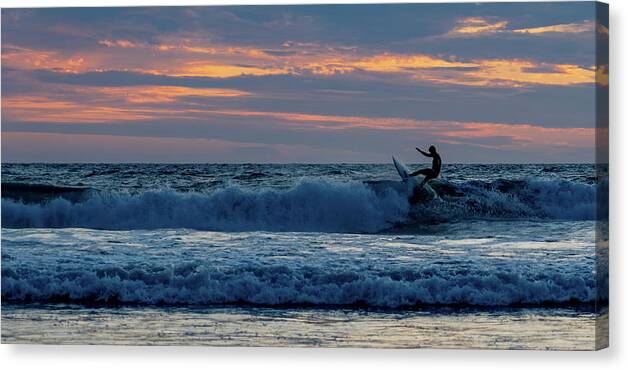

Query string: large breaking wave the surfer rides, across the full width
2 179 608 232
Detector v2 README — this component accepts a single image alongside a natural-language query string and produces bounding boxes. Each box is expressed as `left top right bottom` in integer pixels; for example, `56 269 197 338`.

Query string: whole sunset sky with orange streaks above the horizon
2 2 608 163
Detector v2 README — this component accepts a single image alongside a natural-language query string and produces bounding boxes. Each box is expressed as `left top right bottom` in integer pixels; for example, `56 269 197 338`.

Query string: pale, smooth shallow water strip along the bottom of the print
2 305 608 350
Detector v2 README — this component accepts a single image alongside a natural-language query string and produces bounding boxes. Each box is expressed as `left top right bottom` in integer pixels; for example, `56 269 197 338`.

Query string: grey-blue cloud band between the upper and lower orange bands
17 70 595 132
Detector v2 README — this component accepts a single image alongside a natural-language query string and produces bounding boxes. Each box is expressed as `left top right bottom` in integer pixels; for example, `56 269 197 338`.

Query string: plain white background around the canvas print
0 0 628 370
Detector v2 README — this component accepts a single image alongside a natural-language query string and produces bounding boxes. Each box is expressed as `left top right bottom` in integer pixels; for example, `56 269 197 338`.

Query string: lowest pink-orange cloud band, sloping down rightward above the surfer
3 93 595 149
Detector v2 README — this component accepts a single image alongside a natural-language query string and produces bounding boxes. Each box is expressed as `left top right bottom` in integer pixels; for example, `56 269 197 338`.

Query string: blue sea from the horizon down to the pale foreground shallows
2 164 608 310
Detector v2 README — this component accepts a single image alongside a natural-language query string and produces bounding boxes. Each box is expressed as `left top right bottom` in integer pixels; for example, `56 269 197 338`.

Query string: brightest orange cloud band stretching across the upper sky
2 33 605 87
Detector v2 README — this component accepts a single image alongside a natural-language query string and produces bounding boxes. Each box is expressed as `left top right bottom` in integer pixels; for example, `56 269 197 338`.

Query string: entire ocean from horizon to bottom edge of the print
2 164 608 349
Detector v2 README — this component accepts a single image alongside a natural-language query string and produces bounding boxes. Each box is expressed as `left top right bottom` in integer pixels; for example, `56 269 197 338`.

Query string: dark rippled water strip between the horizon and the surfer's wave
2 164 604 191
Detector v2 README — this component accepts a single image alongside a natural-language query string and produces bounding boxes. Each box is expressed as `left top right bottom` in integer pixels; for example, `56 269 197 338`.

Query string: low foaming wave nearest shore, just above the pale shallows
2 263 608 308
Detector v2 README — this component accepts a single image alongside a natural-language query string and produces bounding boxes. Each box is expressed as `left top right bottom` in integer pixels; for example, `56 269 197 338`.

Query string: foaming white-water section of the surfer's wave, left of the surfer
2 180 409 232
